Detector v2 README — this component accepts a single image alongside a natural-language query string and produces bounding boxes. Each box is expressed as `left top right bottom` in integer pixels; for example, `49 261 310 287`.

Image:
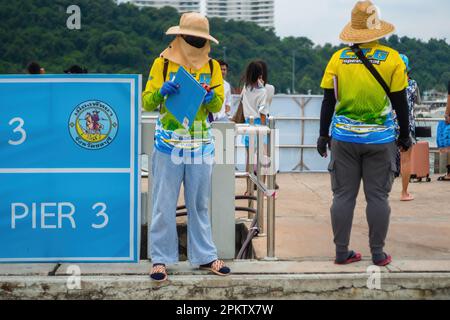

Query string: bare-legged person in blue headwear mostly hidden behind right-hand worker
400 54 420 201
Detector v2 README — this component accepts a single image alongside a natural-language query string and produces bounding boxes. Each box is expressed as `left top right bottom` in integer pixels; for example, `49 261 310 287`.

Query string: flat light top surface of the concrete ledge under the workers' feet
0 260 450 276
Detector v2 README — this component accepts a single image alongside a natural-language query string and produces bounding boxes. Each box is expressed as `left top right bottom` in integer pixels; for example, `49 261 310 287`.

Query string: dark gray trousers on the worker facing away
328 140 397 256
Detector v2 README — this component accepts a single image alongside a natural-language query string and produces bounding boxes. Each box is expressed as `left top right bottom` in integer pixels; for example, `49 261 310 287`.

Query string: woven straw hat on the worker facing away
339 0 395 43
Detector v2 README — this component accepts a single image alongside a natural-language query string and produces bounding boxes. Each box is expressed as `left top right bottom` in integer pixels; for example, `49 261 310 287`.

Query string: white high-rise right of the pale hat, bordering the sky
206 0 275 28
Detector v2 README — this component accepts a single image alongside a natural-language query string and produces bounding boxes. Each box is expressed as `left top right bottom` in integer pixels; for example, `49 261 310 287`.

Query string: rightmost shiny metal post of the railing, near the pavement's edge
267 117 276 259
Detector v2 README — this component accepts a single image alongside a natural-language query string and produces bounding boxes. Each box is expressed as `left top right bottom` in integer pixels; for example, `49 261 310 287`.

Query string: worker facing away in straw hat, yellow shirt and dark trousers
317 1 412 266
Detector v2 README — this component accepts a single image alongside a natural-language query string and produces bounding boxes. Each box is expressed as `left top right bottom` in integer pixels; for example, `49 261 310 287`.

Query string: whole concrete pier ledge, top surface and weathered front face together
0 261 450 300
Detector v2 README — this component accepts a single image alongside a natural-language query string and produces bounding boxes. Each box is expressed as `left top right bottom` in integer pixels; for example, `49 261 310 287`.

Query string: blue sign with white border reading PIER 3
0 75 141 263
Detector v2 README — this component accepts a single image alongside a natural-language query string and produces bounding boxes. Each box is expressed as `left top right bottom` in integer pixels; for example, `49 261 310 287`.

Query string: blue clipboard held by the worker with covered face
166 67 206 130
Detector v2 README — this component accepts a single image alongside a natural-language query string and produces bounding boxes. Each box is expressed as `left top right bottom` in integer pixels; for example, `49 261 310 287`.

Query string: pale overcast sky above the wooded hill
275 0 450 44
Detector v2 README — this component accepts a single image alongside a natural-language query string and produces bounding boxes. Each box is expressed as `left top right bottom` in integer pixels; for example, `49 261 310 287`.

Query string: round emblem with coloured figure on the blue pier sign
69 100 119 150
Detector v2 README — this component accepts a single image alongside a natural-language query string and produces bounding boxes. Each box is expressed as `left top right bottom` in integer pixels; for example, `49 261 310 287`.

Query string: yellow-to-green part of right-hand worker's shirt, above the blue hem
321 42 408 125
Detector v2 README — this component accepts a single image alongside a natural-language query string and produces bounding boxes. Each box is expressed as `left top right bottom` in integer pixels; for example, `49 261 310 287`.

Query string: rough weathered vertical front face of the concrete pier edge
0 273 450 300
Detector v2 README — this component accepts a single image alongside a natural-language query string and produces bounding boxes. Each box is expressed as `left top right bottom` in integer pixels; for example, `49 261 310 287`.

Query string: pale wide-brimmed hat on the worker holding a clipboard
166 12 219 44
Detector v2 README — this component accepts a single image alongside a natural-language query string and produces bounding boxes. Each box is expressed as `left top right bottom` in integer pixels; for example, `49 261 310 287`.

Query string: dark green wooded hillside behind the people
0 0 450 93
